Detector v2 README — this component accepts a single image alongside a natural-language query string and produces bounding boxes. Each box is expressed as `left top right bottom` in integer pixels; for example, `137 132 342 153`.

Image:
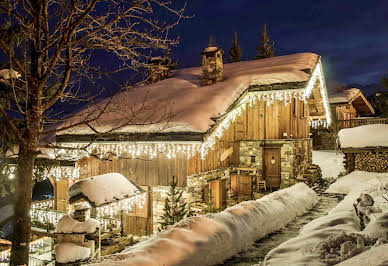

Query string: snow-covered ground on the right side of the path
264 172 388 266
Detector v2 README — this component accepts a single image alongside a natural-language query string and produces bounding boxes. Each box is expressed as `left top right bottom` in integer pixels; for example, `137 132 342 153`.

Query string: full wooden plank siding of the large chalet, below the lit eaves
79 99 310 186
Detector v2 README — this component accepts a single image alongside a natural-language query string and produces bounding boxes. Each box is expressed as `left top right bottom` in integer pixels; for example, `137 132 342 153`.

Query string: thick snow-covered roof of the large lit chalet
57 53 319 135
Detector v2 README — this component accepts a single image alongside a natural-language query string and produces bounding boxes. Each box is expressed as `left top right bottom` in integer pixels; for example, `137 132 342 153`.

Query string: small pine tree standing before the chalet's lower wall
159 176 189 230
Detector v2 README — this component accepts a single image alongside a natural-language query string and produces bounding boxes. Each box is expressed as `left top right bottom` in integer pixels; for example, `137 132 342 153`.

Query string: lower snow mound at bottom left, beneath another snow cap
55 242 90 263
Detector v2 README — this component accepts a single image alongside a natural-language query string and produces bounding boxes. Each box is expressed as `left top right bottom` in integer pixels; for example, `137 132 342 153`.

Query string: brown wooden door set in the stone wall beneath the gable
263 147 281 188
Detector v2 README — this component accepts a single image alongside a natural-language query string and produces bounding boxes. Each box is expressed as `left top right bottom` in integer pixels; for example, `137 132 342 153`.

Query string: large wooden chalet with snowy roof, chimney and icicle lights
50 50 330 233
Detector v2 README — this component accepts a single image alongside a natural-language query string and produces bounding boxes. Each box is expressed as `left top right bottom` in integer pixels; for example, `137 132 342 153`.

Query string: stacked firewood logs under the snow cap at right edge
354 152 388 173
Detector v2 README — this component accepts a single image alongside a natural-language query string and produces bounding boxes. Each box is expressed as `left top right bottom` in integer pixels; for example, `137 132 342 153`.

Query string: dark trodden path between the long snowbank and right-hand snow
221 185 341 266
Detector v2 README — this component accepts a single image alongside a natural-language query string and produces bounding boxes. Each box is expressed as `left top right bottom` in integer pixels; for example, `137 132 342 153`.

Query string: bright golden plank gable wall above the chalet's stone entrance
187 99 310 175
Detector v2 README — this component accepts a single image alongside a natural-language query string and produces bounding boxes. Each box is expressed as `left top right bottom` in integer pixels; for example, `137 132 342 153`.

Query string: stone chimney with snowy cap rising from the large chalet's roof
201 47 224 86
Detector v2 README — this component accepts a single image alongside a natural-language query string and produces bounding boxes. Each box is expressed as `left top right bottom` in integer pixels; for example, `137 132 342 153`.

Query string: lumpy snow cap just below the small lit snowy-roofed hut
56 215 100 234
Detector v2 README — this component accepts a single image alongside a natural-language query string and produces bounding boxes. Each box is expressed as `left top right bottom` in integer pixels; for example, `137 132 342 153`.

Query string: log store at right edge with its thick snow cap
338 124 388 173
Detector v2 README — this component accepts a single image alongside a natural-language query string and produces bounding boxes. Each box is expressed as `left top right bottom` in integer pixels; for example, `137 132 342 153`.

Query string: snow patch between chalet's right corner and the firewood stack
313 151 346 179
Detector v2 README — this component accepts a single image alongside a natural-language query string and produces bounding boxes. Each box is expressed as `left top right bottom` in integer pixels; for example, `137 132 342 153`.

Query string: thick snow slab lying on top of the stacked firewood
338 124 388 148
